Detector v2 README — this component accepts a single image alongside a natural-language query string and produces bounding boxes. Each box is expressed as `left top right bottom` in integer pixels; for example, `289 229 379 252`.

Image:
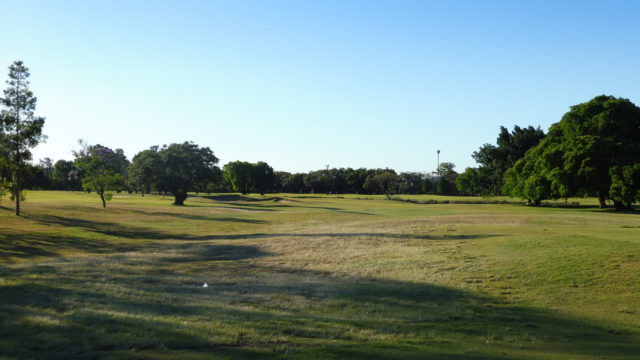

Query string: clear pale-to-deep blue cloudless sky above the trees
0 0 640 172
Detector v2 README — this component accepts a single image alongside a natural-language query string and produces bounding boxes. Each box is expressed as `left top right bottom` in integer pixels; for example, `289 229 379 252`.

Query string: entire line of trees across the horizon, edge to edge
0 61 640 211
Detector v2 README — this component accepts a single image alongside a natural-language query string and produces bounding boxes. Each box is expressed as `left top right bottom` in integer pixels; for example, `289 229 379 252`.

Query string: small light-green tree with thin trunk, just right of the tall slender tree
72 140 122 207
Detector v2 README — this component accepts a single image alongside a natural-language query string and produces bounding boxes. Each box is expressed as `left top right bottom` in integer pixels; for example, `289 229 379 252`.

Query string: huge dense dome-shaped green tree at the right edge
504 95 640 209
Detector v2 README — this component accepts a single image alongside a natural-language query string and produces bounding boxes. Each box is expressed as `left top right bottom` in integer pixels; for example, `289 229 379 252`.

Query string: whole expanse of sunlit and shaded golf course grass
0 192 640 359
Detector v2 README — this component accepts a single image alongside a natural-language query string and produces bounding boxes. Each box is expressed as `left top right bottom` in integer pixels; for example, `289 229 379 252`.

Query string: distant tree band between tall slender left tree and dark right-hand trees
13 145 458 206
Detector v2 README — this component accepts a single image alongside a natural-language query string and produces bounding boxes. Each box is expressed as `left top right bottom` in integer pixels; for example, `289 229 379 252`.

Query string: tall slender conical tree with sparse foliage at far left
0 61 46 216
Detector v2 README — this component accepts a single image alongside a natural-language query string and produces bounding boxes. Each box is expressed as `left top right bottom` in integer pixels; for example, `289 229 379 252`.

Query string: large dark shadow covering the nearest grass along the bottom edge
0 258 638 360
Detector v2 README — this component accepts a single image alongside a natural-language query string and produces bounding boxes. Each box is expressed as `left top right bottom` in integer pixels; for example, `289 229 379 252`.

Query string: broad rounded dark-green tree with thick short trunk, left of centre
159 141 218 205
